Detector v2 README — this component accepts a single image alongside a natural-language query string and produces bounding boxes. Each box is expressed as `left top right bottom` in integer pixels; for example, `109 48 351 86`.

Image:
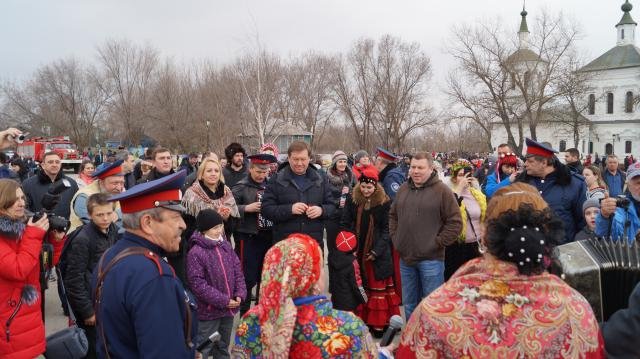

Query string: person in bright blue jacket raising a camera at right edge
595 162 640 242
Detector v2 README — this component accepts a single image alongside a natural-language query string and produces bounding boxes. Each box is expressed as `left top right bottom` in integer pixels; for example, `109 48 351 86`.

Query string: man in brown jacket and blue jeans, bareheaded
389 152 462 318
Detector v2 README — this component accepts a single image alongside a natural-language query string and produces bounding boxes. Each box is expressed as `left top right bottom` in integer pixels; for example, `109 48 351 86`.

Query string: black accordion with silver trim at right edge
551 238 640 321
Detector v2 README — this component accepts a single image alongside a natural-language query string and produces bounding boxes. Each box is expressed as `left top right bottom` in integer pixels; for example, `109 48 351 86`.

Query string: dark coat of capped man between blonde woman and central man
231 175 273 234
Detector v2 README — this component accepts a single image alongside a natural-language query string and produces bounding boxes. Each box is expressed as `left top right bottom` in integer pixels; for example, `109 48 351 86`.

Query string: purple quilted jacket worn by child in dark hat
187 231 247 320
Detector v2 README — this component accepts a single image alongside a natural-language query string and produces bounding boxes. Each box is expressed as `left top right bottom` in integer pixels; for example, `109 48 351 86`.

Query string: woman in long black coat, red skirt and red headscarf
338 169 400 335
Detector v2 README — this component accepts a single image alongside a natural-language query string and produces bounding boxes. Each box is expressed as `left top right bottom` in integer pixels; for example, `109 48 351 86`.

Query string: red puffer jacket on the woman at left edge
0 226 64 359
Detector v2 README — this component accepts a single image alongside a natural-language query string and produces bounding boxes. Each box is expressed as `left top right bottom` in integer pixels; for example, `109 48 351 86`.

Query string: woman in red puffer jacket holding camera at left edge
0 179 64 358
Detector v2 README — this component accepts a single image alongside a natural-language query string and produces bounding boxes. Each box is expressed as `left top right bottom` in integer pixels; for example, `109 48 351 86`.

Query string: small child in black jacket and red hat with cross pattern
329 231 368 312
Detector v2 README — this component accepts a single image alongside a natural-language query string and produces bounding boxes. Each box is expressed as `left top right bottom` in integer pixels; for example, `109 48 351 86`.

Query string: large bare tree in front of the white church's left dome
447 12 579 153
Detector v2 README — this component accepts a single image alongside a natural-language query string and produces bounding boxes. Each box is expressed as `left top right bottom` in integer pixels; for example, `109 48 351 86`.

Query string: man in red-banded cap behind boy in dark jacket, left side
69 160 125 231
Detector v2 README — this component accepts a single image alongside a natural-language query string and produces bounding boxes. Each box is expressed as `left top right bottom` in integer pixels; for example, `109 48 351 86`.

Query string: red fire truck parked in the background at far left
17 136 82 173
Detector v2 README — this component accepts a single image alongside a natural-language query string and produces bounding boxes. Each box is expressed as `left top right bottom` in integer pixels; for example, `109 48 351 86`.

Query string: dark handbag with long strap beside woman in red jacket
44 267 89 359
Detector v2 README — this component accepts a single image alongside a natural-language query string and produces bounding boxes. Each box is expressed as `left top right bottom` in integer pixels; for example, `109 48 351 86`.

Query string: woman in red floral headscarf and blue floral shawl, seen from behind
231 234 378 358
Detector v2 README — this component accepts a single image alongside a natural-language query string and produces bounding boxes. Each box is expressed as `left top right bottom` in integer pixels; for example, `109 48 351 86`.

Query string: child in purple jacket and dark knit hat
187 209 247 358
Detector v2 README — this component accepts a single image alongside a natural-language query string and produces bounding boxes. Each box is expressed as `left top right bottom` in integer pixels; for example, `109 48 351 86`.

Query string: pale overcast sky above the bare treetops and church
0 0 640 91
